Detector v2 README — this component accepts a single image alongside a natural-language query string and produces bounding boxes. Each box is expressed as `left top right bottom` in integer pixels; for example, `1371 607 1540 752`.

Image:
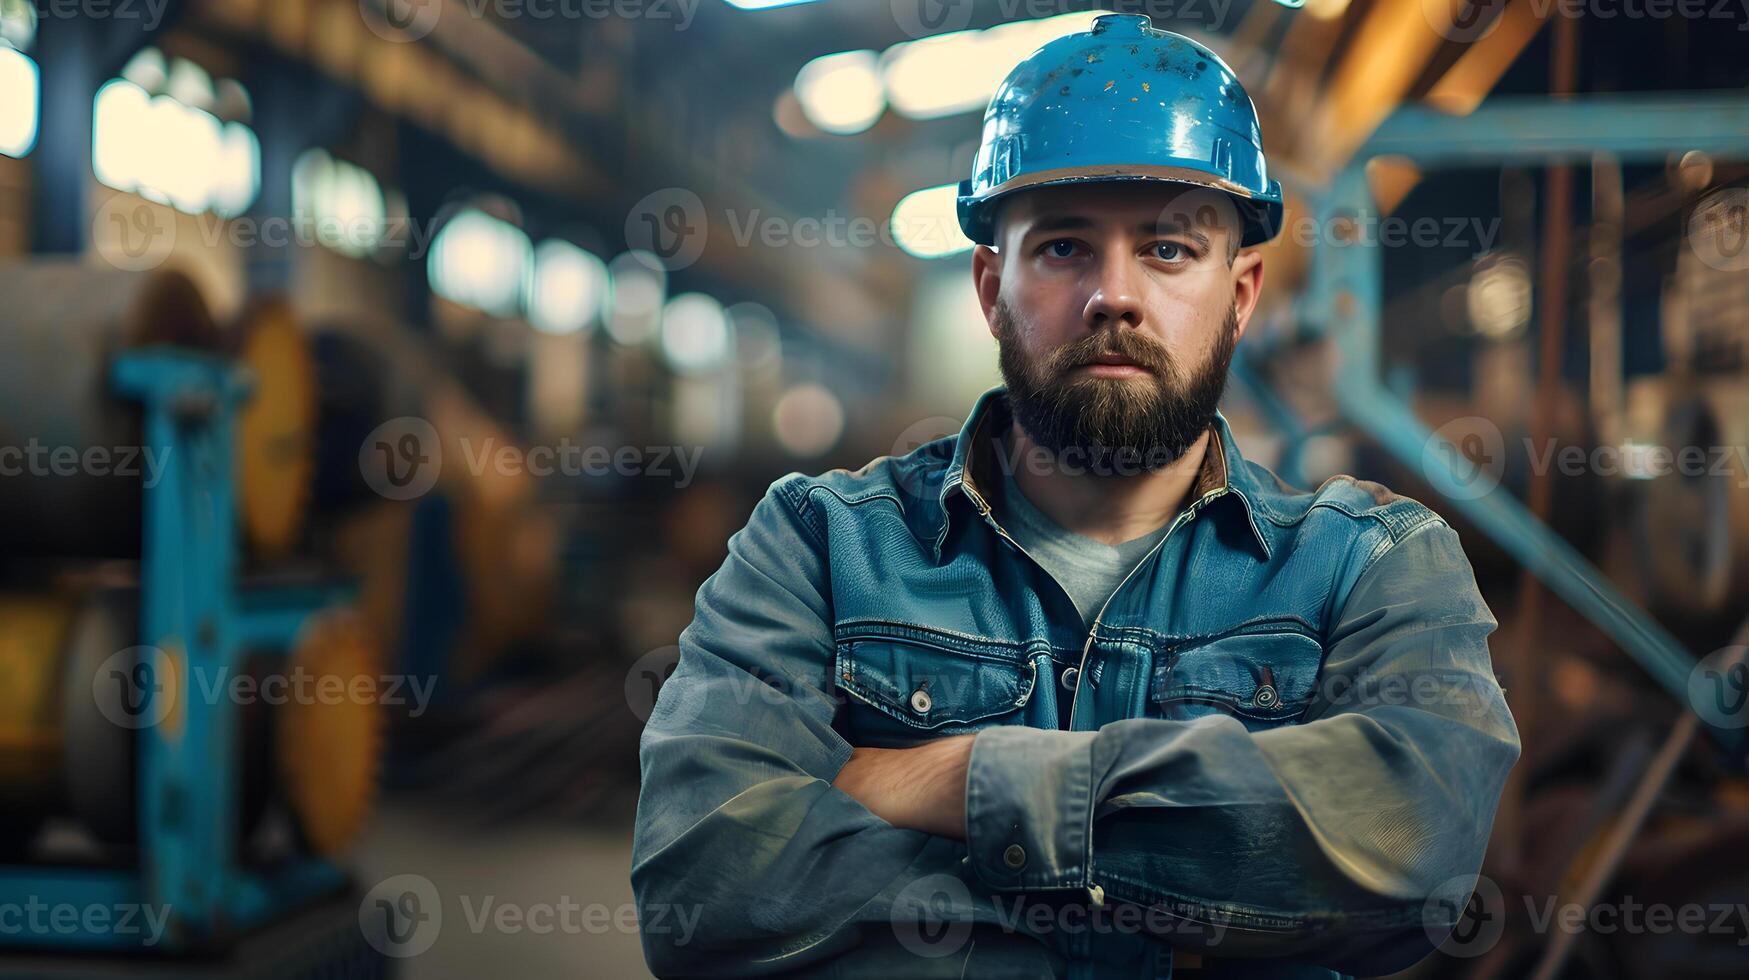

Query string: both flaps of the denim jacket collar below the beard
934 385 1270 562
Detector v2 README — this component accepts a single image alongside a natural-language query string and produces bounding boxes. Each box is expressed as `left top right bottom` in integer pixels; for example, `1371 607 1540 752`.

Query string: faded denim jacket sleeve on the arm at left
631 474 939 977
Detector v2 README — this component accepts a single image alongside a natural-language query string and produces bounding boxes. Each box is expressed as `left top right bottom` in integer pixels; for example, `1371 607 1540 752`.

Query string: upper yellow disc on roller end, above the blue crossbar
236 299 317 558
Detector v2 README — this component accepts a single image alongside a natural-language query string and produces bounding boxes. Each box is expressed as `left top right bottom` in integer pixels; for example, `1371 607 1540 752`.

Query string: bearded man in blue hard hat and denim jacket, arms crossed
631 16 1518 978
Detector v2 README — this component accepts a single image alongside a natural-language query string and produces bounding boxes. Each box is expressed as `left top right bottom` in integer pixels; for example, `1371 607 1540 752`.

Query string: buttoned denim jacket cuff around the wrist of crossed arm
965 726 1098 891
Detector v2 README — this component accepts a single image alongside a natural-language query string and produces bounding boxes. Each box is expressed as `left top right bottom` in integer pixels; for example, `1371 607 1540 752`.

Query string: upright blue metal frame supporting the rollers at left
0 350 348 950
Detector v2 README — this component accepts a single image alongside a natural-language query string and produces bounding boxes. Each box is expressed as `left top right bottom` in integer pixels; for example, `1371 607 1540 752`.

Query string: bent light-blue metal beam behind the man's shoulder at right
1298 93 1749 747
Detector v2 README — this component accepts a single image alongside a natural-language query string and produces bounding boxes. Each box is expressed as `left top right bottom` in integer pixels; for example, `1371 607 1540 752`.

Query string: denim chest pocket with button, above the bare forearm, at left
834 637 1034 746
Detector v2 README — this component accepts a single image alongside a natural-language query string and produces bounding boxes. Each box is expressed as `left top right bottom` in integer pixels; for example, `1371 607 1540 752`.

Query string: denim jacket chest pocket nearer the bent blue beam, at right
1151 630 1324 732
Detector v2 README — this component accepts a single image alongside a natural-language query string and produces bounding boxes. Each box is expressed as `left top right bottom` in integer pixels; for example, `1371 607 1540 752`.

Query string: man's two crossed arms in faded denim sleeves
631 481 1518 975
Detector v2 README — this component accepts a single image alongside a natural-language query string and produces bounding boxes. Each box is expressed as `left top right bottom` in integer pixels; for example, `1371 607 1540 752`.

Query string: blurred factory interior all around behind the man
0 0 1749 978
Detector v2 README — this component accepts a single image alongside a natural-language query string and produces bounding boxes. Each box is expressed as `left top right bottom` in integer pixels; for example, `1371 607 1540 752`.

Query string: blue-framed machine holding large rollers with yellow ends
0 263 383 977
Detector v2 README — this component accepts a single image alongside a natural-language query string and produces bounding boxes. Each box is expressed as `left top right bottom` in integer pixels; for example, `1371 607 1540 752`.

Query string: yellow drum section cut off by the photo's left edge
0 593 73 807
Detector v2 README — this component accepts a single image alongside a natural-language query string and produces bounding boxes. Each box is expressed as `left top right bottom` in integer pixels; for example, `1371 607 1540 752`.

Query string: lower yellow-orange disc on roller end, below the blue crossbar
275 609 390 854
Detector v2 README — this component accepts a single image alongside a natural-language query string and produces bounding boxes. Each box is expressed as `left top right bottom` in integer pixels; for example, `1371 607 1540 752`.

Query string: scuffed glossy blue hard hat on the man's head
958 14 1282 245
